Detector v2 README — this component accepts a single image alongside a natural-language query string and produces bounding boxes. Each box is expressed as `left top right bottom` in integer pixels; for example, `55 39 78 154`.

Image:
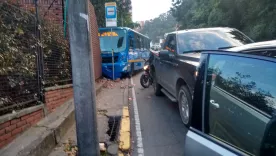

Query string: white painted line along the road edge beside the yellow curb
130 78 144 156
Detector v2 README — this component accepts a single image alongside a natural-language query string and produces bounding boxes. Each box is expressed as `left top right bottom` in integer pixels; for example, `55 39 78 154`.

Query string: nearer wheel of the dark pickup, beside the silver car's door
178 85 192 127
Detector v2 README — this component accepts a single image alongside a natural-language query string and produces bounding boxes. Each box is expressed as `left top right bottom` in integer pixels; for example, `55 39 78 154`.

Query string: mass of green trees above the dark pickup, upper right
171 0 276 41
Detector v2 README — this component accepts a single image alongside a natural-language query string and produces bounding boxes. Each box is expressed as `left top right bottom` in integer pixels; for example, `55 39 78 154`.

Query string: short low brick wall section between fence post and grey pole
45 87 73 113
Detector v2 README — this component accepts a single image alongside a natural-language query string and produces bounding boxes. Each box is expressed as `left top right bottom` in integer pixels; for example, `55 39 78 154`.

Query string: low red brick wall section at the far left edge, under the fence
0 109 44 149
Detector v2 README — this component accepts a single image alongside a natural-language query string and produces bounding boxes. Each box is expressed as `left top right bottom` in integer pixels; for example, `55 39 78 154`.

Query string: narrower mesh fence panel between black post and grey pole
41 23 72 87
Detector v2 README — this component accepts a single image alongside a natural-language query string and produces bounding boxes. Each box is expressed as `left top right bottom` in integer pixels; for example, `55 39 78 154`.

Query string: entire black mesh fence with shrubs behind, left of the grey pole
0 2 72 116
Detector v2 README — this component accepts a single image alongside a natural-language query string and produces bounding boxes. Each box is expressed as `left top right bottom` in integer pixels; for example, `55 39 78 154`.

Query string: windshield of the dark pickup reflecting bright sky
177 29 253 53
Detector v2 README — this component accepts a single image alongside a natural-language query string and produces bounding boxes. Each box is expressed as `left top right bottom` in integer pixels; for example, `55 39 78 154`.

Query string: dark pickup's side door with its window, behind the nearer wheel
161 34 177 94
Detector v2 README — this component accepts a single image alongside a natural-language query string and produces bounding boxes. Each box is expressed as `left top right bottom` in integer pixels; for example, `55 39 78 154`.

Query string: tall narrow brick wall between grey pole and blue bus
88 0 102 79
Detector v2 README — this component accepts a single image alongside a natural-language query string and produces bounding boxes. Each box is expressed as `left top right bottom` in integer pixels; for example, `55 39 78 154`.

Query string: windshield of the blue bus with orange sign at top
98 30 126 53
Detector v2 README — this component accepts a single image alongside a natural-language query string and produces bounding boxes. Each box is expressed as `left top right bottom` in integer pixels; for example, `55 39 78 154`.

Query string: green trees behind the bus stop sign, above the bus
91 0 137 28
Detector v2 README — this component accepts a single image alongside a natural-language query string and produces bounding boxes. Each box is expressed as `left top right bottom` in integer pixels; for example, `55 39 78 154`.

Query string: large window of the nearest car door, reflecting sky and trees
205 55 276 155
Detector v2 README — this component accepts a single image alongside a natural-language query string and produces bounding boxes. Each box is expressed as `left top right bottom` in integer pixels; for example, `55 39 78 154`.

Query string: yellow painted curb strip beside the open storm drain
119 107 130 151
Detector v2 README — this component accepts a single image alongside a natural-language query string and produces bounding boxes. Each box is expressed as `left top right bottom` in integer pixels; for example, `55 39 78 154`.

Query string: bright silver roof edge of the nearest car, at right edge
227 40 276 52
